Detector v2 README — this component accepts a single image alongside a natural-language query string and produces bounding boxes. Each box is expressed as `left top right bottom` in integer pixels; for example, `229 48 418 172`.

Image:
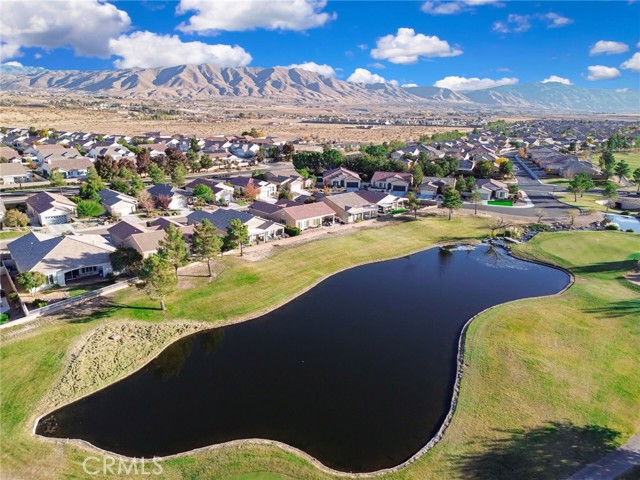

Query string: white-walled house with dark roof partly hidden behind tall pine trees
187 208 284 244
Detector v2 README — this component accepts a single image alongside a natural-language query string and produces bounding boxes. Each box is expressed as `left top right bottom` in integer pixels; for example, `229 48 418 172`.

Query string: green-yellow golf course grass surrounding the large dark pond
0 218 640 480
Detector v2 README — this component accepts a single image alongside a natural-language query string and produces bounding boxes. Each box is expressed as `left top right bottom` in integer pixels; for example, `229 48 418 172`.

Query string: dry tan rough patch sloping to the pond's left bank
38 321 211 412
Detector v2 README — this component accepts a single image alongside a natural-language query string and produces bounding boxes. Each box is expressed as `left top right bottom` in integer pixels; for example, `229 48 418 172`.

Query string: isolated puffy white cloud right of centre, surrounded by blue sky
371 28 462 65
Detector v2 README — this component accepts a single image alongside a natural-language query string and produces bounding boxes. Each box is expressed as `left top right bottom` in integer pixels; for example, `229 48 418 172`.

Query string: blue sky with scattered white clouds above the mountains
0 0 640 90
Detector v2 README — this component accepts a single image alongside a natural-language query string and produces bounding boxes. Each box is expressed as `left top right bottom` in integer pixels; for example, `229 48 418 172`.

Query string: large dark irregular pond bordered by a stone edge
37 246 569 472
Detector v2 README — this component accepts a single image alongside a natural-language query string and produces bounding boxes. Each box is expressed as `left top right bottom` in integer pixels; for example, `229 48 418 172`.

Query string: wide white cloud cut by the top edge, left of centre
177 0 336 34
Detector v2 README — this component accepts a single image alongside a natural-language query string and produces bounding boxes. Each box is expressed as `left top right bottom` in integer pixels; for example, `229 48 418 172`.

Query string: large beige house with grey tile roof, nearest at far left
7 232 115 286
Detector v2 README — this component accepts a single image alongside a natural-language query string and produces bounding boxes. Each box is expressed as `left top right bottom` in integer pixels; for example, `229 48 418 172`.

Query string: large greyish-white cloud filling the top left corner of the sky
0 0 131 58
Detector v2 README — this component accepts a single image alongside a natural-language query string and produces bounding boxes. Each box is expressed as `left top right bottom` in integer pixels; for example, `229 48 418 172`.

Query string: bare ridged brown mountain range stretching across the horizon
0 64 640 113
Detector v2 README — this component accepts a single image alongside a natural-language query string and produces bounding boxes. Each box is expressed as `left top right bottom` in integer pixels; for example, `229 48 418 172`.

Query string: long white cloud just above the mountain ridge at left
109 32 251 68
